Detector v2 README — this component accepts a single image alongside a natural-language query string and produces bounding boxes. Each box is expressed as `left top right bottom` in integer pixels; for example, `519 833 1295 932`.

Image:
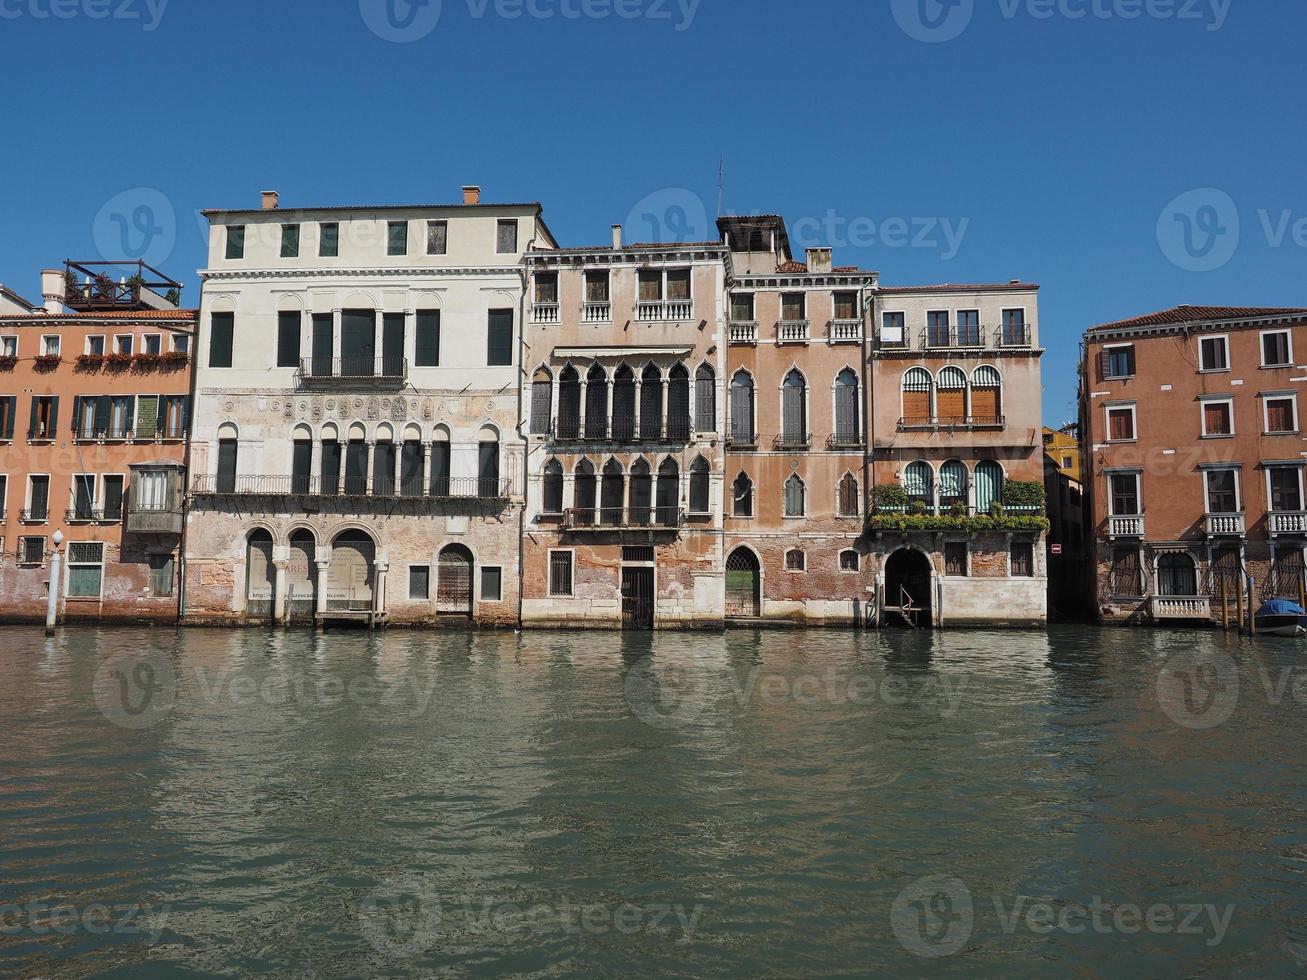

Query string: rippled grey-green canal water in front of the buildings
0 627 1307 977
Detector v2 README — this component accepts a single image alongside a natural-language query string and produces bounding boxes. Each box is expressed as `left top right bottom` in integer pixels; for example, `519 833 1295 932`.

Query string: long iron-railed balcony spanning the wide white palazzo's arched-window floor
191 474 511 502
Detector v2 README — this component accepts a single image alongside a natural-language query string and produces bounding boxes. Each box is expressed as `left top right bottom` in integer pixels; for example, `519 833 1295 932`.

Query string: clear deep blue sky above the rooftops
0 0 1307 423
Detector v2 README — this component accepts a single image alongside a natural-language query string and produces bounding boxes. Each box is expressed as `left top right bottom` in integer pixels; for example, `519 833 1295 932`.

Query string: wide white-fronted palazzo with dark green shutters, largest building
186 187 554 626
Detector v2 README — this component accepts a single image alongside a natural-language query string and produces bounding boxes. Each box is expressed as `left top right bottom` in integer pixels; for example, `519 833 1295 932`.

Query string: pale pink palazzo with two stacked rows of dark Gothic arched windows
521 226 727 629
